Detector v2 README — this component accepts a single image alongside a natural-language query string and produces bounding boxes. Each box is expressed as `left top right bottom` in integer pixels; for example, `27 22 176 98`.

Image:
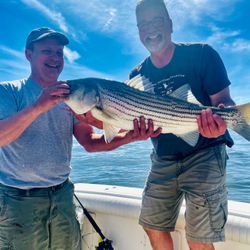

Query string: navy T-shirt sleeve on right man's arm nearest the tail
201 45 231 95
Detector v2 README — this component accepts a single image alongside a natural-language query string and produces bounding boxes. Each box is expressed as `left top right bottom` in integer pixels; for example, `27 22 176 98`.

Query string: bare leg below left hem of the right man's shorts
143 227 174 250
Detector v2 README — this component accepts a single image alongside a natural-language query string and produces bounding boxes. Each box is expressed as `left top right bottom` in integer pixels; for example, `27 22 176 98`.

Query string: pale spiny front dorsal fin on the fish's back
124 75 154 93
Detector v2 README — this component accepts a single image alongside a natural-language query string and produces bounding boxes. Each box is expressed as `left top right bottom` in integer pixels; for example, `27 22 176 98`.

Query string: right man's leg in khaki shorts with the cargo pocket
178 145 227 250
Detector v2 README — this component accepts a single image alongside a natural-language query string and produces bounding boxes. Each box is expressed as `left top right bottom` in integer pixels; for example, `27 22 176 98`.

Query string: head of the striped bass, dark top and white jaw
65 79 98 114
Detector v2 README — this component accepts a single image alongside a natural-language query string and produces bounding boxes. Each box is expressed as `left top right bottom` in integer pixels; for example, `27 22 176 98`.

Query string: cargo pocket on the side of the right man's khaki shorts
205 187 228 231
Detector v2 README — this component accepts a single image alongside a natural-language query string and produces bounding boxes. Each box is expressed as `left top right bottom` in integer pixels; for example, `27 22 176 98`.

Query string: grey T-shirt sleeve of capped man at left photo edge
0 83 17 120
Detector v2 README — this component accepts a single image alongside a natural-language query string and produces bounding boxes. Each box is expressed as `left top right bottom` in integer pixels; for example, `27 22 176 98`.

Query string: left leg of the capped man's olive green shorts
0 187 50 250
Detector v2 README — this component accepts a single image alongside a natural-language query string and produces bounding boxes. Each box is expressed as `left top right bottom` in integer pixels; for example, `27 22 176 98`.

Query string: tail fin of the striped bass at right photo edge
231 103 250 141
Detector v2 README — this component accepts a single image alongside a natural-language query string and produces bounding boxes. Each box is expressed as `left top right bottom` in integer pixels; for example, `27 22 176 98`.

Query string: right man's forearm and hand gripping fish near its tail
197 87 235 138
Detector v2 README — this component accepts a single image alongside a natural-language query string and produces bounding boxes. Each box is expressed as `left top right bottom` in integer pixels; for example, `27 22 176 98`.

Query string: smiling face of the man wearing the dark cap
25 38 64 86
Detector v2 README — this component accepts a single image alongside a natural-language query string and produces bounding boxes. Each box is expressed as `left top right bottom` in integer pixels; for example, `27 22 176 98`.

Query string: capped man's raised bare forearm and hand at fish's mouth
0 84 69 147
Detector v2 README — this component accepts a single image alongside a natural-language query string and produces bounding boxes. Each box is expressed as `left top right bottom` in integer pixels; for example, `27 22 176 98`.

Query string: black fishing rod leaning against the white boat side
74 193 114 250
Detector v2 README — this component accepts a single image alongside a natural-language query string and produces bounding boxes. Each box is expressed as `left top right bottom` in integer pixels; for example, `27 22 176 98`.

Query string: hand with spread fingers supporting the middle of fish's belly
127 116 162 141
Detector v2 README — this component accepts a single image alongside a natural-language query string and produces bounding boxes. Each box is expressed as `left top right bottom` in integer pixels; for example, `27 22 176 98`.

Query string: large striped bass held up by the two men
65 77 250 146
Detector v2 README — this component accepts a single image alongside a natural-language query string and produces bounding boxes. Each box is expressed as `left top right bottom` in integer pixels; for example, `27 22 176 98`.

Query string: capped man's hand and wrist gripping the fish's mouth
34 82 70 113
